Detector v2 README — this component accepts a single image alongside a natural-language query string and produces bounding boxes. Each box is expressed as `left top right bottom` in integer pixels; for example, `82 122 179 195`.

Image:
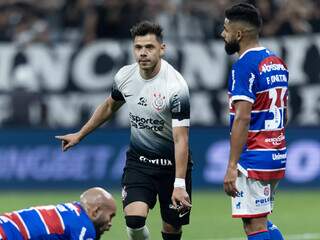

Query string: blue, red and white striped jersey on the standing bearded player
228 47 289 180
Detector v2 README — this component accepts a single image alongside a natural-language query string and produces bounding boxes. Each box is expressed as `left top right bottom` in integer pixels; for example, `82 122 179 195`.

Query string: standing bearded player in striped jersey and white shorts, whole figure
221 3 289 240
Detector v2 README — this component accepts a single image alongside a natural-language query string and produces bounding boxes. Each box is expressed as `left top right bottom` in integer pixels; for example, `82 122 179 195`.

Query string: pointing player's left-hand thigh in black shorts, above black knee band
122 168 157 212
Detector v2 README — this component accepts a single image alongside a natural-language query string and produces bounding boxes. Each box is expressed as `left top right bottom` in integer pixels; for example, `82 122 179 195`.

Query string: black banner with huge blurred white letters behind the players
0 35 320 128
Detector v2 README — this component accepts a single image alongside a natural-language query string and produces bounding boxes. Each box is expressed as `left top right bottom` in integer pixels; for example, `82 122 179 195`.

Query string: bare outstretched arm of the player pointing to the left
56 96 125 151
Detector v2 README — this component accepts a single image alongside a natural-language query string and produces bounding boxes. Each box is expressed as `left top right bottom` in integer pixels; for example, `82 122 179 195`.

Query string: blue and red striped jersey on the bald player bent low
0 202 96 240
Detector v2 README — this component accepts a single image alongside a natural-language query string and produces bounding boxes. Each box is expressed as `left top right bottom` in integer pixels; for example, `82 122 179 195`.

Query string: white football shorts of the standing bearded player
231 171 279 218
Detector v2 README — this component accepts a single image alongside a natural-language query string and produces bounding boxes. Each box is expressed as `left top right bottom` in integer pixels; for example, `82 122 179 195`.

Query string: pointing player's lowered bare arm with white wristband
172 127 191 208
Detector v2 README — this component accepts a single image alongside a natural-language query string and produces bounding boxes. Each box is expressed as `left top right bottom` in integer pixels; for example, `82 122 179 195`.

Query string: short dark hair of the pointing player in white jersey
130 21 163 42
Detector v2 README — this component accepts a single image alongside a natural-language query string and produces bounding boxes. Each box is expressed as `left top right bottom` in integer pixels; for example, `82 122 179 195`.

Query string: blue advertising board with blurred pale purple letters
0 128 320 190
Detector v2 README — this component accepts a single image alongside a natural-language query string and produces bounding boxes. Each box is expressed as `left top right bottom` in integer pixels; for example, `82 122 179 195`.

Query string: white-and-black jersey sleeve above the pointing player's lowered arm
170 77 190 127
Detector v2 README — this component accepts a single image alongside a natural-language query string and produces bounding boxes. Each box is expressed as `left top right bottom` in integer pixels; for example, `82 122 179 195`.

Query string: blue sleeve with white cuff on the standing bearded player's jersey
231 61 256 103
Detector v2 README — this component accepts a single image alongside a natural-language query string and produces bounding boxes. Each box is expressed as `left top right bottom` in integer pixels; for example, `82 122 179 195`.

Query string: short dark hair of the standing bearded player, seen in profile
225 3 262 30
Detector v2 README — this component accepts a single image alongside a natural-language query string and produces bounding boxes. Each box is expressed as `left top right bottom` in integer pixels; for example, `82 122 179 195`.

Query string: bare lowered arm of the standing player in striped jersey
224 101 252 197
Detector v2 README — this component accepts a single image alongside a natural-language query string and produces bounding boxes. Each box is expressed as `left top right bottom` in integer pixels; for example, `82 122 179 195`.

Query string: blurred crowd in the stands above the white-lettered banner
0 0 320 44
